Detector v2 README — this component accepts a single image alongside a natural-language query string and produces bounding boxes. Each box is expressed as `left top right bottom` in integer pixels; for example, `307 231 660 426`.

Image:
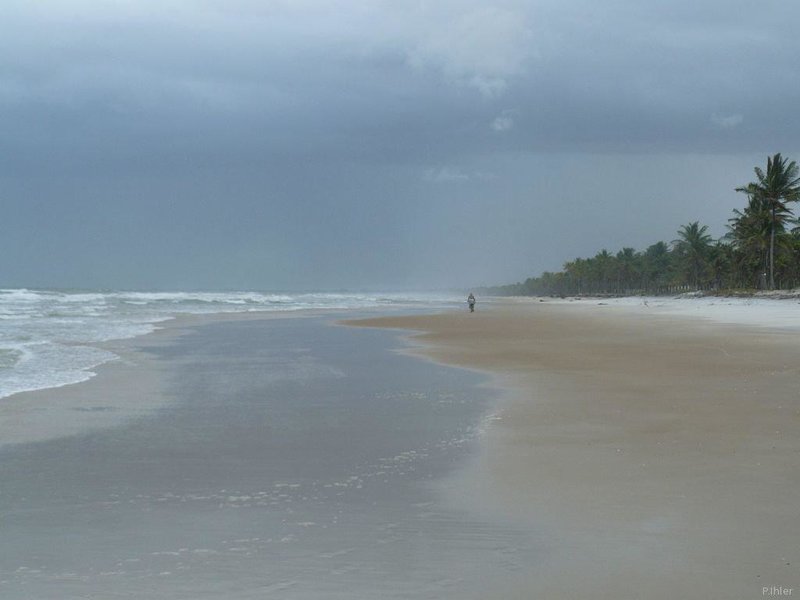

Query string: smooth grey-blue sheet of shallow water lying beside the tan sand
0 318 535 600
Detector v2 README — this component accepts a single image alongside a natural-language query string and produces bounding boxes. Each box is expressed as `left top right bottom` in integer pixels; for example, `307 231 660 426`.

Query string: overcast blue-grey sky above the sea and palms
0 0 800 290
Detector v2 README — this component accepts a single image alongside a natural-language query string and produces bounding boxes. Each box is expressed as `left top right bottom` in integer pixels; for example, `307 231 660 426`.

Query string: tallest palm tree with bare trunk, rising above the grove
736 152 800 289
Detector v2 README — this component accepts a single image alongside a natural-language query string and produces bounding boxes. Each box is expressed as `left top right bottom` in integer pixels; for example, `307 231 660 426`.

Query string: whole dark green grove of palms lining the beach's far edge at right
485 154 800 296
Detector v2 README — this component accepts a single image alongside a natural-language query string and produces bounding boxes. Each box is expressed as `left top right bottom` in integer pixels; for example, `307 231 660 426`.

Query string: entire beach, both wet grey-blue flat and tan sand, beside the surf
0 299 800 600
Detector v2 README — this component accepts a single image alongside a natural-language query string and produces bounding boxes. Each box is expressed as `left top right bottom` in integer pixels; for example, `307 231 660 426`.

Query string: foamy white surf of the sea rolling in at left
0 289 460 398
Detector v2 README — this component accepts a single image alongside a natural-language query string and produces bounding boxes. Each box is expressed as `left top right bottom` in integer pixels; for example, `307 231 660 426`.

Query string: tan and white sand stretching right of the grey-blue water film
350 301 800 600
